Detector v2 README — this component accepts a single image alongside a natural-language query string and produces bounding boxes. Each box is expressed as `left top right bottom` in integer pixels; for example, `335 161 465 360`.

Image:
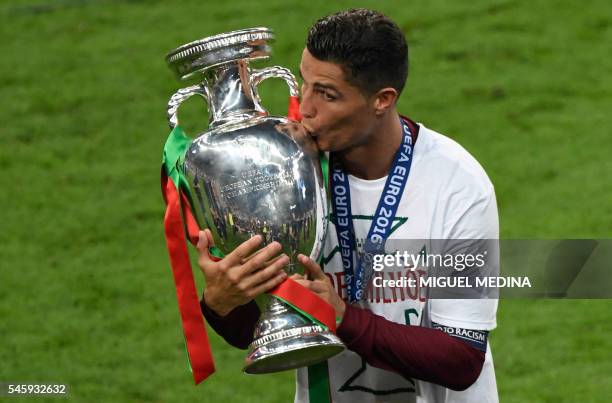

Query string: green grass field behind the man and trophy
0 0 612 403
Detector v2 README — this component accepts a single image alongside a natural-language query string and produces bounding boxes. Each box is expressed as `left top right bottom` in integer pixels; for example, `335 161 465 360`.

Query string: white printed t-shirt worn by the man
295 124 499 403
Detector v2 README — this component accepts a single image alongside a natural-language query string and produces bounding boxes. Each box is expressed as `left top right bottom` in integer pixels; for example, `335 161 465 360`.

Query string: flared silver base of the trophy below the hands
244 298 345 374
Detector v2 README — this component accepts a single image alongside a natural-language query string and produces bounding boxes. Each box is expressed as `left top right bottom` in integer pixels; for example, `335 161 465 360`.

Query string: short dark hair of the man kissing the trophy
306 9 408 95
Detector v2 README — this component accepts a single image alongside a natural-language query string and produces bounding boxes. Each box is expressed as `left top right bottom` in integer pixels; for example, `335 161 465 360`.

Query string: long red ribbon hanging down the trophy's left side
162 175 215 385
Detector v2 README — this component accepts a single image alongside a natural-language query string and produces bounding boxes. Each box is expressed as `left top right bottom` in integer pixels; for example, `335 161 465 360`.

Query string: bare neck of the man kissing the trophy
338 111 403 180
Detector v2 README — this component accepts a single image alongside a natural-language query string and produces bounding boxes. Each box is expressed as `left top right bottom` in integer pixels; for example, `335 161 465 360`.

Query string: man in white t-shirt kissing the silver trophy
198 10 498 403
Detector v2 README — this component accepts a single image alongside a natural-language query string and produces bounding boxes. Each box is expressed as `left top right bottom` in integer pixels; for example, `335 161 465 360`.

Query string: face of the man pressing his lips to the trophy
300 49 376 151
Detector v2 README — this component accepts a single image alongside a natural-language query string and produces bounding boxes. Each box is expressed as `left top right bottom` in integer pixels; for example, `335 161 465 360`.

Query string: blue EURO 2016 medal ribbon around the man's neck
331 118 414 303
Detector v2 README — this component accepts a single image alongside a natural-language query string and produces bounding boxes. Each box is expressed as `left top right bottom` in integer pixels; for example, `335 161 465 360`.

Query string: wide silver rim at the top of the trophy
166 27 274 80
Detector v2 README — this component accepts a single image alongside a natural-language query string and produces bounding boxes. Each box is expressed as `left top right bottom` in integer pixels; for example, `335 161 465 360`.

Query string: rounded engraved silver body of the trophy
184 116 326 266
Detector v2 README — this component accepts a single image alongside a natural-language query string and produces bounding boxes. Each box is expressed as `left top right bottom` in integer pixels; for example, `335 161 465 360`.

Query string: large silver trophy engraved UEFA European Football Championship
166 28 344 374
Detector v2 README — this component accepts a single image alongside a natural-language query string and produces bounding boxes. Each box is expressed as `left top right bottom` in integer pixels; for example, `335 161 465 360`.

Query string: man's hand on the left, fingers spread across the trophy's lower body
197 229 289 316
